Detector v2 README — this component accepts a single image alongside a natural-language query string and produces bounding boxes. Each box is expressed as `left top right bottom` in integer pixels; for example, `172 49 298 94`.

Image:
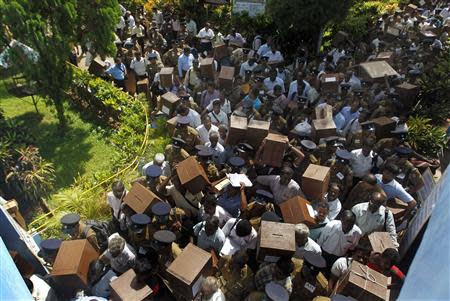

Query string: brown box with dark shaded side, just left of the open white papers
177 156 209 194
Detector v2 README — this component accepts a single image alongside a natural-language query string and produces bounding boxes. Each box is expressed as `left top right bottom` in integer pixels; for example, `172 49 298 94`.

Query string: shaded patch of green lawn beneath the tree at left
12 112 93 189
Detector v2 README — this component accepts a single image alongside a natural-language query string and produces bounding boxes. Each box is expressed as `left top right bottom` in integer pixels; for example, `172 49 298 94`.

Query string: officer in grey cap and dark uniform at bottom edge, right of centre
289 251 328 300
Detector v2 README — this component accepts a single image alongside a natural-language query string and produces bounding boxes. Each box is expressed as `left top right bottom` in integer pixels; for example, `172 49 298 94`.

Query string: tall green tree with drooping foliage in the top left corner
0 0 120 133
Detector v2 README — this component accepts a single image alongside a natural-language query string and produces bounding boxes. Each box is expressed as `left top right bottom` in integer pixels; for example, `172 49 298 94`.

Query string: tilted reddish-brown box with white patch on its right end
278 196 317 227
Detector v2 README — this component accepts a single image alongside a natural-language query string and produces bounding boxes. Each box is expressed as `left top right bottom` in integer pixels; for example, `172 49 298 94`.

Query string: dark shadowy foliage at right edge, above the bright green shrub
414 50 450 126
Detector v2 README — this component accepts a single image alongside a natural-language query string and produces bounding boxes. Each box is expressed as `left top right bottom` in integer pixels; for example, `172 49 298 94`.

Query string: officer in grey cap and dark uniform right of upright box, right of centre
330 149 353 199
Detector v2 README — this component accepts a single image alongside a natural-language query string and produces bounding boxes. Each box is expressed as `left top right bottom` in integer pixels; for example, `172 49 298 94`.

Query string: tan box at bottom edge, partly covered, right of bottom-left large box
110 269 153 301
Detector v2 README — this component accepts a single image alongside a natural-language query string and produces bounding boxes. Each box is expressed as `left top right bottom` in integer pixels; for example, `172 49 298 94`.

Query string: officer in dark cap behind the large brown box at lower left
60 213 100 251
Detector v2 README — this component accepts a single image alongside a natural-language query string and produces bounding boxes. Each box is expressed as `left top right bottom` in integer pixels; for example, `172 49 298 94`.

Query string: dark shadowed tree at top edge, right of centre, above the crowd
266 0 355 54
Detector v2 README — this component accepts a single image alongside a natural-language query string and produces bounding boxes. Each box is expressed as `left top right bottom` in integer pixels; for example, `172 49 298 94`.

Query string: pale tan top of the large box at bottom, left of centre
167 243 211 285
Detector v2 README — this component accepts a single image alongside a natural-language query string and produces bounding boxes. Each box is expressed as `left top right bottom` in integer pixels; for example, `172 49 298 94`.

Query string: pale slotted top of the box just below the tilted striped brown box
259 221 296 252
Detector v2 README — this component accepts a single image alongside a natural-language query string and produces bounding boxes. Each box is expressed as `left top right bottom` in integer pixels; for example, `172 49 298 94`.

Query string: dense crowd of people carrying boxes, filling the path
25 1 450 301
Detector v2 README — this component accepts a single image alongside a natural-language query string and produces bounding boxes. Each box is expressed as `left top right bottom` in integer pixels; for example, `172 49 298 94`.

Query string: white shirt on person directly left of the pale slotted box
220 218 258 256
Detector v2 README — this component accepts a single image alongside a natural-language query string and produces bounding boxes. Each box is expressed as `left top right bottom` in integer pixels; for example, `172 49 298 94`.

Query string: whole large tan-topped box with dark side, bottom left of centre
166 243 212 300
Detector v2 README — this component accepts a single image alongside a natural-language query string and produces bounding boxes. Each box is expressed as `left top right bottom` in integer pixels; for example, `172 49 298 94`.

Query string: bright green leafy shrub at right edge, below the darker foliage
407 116 448 158
